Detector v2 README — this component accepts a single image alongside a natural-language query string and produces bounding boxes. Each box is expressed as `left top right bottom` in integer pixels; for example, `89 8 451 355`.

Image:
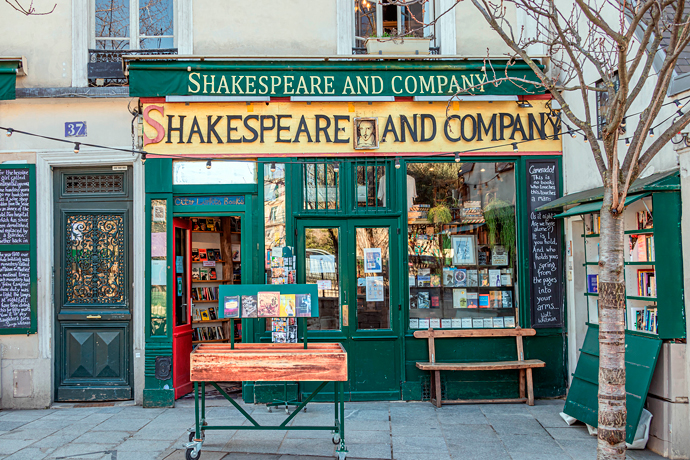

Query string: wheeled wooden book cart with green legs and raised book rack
185 284 347 460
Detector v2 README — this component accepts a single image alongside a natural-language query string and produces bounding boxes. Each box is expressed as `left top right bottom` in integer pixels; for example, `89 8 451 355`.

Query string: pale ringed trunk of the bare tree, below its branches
597 178 627 460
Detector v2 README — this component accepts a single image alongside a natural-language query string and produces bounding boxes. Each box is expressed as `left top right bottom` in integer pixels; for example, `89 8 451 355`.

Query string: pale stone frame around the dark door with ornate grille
36 147 146 402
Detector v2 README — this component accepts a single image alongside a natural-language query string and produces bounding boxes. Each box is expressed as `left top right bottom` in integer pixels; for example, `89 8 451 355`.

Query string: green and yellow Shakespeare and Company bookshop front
128 59 566 406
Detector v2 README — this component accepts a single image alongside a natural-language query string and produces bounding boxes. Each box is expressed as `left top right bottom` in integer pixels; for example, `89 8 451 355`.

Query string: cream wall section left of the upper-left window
0 0 72 88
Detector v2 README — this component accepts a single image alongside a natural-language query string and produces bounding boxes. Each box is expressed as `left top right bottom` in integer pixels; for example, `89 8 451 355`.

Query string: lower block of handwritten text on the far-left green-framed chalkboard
0 251 31 329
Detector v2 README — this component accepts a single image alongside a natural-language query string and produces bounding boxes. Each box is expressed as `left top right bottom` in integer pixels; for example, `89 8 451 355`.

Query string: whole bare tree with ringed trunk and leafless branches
446 0 690 460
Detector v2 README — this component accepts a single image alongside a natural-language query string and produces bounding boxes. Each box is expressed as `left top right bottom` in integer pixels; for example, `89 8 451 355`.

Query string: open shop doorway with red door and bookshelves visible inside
173 214 243 399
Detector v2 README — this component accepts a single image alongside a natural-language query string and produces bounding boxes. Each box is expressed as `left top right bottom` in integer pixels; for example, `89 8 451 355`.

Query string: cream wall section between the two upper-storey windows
193 0 337 55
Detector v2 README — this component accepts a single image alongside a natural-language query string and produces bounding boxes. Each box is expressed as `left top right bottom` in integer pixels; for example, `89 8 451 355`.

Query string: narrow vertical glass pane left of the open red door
151 200 168 335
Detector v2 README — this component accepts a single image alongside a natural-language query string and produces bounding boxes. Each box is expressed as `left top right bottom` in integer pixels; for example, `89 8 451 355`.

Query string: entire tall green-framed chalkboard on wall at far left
0 164 37 335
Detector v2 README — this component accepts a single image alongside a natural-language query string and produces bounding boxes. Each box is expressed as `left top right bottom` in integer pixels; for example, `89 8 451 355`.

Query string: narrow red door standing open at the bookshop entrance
173 217 193 399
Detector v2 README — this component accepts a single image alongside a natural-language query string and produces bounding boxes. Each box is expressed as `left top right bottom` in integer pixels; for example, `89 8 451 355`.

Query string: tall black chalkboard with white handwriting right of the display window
527 160 563 327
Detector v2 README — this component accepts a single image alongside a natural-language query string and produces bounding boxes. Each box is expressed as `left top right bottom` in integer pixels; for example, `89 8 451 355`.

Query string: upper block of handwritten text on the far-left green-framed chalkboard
0 169 30 244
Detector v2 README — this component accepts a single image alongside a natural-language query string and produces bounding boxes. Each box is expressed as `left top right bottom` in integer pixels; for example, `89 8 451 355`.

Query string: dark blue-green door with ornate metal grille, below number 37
54 168 133 401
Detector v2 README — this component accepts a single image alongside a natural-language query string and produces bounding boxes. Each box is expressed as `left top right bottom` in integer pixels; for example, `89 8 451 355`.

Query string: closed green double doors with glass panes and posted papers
297 218 402 401
